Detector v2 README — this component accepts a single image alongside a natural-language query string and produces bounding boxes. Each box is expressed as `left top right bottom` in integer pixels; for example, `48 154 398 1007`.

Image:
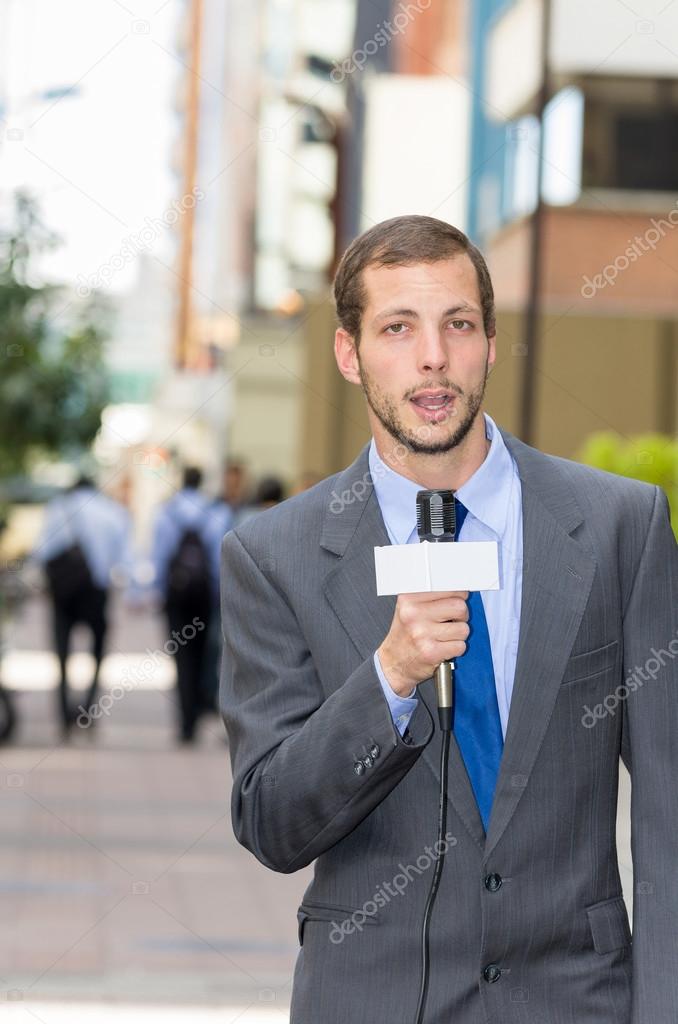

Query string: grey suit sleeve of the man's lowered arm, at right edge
624 487 678 1024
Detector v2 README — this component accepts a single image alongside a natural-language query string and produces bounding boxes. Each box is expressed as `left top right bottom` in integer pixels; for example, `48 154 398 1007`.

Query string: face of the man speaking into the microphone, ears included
335 255 496 455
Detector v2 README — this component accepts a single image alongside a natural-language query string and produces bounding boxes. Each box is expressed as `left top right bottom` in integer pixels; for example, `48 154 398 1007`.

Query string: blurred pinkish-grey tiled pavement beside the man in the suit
0 589 631 1024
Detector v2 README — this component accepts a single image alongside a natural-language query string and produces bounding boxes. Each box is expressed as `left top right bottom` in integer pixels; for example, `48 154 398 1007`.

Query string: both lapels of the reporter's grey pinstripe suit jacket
321 431 595 857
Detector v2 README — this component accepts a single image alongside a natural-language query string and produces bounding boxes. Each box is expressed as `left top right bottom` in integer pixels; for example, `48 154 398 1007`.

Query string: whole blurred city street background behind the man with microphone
0 0 678 1024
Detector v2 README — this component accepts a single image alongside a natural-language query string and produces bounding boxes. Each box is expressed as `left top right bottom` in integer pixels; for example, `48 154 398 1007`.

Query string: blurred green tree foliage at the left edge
0 194 108 478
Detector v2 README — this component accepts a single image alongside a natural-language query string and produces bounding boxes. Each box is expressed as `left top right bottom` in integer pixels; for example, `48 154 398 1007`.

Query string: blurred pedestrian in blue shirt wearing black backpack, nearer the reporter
152 466 213 743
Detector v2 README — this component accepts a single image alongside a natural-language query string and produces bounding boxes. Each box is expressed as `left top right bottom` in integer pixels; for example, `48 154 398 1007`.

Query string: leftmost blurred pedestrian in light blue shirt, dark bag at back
34 475 131 737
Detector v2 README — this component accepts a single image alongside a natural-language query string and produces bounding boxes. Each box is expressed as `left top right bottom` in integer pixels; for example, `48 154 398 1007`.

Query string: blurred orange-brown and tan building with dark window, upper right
469 0 678 456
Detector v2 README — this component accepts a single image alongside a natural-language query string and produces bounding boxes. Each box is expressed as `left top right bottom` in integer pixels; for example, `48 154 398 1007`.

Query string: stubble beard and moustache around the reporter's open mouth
358 358 489 455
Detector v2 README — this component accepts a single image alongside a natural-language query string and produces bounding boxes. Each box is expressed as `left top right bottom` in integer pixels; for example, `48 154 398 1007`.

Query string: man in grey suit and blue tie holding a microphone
221 211 678 1024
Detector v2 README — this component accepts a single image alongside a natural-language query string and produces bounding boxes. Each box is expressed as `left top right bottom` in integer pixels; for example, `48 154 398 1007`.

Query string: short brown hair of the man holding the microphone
334 214 496 344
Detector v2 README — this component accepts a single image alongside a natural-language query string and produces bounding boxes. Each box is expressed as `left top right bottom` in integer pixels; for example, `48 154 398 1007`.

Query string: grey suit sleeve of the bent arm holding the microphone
220 531 433 872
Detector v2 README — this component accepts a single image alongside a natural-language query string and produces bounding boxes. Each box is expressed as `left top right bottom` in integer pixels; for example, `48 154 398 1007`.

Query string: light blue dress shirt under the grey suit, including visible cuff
369 413 522 737
